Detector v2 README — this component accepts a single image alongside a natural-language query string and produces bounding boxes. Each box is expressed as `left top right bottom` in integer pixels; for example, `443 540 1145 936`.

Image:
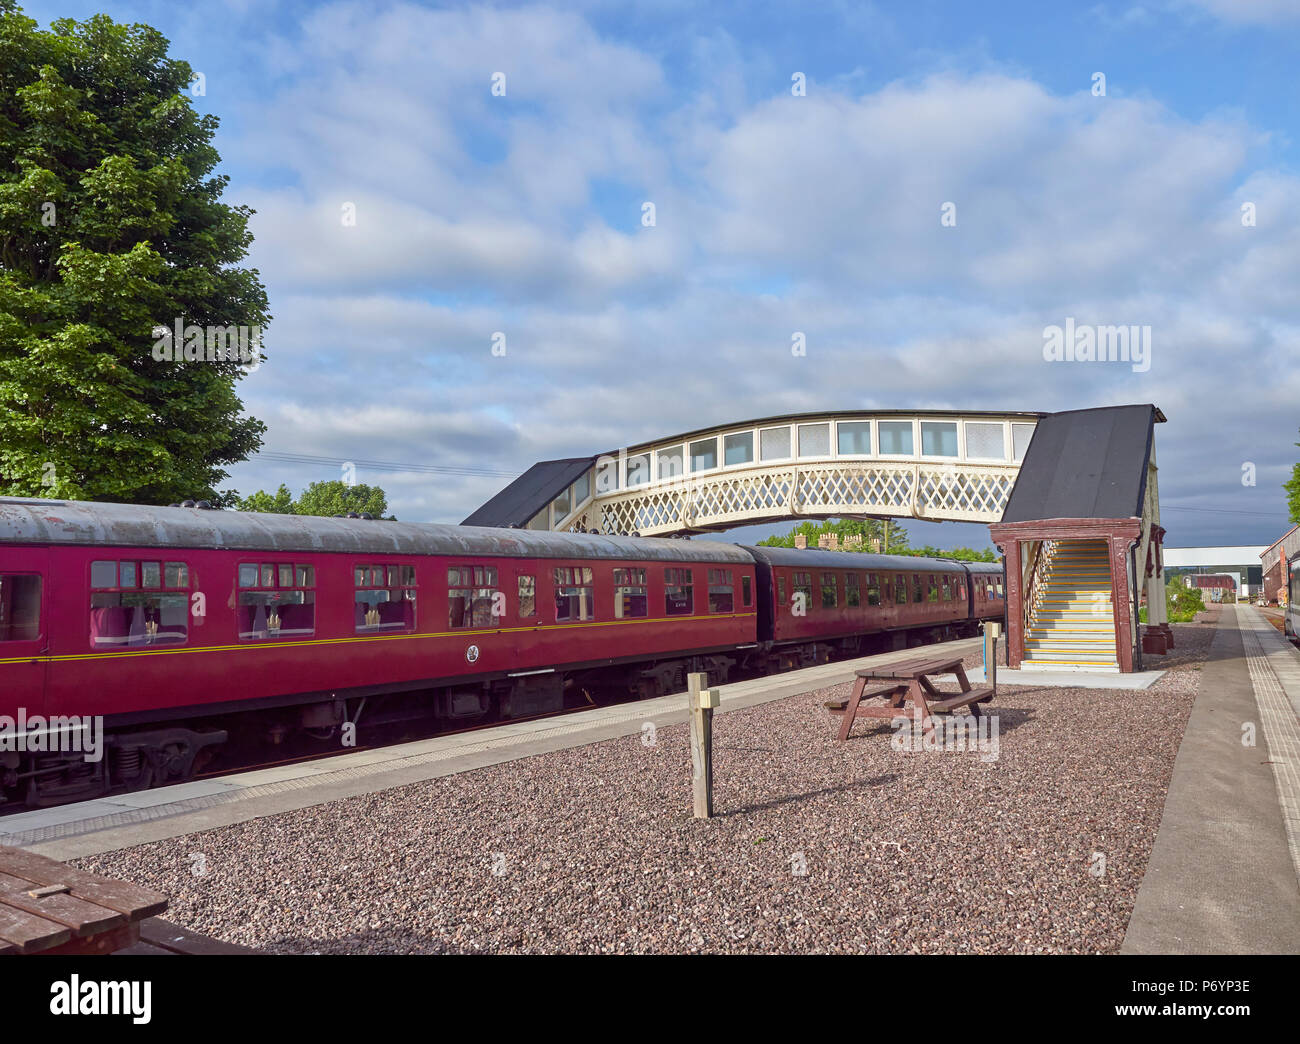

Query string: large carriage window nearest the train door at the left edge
90 562 190 649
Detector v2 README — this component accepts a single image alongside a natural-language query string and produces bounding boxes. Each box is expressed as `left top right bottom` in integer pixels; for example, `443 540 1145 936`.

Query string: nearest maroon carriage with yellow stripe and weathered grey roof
0 498 757 803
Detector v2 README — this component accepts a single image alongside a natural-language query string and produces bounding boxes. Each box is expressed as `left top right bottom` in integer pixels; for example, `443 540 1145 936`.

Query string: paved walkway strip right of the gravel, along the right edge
1121 606 1300 954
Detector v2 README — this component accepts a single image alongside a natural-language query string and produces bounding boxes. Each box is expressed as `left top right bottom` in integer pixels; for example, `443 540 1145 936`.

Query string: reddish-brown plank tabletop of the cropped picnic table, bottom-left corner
0 845 166 954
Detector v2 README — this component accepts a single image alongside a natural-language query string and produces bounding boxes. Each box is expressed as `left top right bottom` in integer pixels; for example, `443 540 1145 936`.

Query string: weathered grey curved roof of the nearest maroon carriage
0 497 753 566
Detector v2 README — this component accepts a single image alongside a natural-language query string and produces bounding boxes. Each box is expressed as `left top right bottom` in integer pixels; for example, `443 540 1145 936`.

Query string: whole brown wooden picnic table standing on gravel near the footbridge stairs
827 657 993 740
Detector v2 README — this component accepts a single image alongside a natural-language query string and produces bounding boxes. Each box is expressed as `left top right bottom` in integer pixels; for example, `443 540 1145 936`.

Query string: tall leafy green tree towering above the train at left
0 0 270 504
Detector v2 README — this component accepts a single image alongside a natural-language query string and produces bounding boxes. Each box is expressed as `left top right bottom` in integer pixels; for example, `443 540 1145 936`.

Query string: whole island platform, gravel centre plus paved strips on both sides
0 607 1300 954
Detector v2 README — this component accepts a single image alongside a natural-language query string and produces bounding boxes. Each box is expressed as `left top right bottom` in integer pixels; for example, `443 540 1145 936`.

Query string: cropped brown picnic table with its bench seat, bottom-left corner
0 845 247 956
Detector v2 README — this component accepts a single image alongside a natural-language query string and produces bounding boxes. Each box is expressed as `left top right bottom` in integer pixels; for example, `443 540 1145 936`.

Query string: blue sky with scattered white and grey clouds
17 0 1300 545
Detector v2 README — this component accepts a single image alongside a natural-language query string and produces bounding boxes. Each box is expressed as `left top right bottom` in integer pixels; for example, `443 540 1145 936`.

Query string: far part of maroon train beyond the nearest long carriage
749 547 1005 663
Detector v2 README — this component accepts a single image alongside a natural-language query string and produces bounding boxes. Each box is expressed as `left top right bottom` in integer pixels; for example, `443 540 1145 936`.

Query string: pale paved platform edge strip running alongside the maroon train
0 638 982 859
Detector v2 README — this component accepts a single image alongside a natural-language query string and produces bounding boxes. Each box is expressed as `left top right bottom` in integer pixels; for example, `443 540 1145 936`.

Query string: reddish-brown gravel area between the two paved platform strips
77 624 1213 953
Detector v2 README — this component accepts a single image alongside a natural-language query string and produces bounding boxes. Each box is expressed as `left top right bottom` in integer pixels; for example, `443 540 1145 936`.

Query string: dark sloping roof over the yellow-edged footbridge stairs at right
1002 403 1165 523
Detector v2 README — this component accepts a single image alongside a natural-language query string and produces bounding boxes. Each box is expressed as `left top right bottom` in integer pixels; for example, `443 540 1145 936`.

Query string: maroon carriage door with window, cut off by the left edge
0 547 49 718
